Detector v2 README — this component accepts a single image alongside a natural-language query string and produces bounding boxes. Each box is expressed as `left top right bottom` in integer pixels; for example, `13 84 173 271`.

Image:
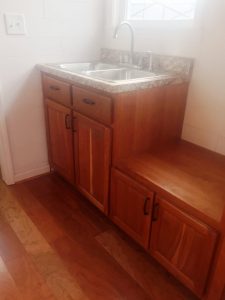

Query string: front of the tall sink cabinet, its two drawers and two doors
43 75 112 214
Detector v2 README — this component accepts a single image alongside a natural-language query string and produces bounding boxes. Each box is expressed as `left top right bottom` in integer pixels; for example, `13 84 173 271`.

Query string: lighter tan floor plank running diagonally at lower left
0 183 87 300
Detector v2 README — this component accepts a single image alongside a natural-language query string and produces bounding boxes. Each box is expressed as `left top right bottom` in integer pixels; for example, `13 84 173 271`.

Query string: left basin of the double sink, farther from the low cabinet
57 62 118 73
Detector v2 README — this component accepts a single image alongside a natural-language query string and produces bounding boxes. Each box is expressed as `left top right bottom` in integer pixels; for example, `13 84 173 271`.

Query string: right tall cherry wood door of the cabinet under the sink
74 114 111 214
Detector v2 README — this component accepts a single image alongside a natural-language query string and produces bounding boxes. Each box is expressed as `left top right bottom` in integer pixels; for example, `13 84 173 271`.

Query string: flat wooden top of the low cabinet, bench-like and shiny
117 141 225 229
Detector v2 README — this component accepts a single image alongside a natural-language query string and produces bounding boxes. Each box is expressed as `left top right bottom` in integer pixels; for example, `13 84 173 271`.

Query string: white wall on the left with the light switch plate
0 0 104 181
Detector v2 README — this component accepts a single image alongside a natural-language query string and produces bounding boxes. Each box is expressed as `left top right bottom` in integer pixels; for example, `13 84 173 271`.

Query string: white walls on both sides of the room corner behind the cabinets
0 0 225 180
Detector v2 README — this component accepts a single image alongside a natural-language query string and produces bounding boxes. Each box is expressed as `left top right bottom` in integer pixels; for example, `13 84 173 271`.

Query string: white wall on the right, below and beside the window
104 0 225 154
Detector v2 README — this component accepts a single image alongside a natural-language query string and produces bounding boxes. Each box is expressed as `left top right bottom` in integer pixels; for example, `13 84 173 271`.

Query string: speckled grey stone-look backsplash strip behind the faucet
101 48 194 79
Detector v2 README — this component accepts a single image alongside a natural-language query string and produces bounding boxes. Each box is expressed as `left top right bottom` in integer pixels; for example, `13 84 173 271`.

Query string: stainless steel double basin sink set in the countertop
56 62 163 83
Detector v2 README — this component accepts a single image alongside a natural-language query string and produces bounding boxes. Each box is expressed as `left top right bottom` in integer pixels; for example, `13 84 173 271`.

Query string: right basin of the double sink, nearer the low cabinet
86 69 156 82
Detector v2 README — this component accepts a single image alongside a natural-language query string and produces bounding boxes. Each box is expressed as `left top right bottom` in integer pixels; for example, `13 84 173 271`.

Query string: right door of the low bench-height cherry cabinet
150 199 217 296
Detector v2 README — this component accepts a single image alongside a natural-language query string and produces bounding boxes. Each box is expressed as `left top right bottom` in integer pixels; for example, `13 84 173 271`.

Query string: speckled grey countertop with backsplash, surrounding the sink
37 49 193 93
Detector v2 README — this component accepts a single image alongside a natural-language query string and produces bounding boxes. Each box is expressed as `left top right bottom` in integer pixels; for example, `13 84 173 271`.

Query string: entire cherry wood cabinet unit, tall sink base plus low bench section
43 74 222 300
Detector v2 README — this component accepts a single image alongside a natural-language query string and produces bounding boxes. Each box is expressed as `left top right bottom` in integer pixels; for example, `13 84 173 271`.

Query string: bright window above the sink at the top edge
126 0 197 21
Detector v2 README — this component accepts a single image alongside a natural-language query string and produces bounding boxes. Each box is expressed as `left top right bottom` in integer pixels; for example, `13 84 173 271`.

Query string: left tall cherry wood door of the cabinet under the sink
46 99 74 183
